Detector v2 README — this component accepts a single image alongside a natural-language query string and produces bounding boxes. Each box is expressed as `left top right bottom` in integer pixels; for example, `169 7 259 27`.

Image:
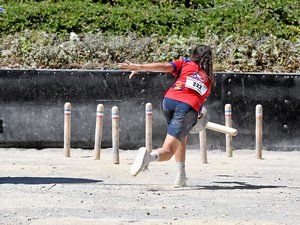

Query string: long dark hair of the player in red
191 45 215 87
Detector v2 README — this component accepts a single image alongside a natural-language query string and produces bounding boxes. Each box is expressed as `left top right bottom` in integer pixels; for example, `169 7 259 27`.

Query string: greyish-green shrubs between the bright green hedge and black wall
0 31 300 72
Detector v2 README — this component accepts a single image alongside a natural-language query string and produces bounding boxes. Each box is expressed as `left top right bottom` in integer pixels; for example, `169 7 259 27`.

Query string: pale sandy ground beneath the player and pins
0 148 300 225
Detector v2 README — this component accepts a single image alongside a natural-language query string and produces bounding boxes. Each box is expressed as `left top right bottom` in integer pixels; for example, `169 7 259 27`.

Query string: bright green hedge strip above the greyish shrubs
0 0 300 41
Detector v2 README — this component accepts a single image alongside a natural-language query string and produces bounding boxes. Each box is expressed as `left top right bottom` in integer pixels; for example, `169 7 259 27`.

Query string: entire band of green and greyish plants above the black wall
0 0 300 72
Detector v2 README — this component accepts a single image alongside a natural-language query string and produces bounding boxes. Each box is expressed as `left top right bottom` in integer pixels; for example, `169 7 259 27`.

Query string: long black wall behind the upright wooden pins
0 70 300 150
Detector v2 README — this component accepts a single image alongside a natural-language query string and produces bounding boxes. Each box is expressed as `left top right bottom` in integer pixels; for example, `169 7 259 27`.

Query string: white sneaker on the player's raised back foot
130 147 150 176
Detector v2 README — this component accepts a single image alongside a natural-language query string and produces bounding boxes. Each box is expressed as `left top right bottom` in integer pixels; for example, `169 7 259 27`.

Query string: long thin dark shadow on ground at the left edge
0 177 103 184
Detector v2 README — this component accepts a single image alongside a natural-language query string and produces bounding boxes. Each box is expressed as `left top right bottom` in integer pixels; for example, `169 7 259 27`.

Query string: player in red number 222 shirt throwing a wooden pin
120 45 215 187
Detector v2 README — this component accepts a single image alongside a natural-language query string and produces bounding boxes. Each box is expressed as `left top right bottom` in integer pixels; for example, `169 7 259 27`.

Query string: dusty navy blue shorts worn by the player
161 98 198 141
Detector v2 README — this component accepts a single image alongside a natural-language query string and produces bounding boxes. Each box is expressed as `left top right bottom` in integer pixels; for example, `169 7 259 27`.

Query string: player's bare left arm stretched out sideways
119 63 173 79
